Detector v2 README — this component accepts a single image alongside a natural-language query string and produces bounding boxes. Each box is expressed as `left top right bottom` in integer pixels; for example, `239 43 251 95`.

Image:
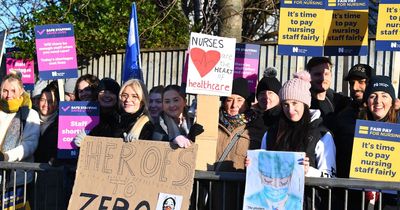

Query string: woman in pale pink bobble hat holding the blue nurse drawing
261 71 336 209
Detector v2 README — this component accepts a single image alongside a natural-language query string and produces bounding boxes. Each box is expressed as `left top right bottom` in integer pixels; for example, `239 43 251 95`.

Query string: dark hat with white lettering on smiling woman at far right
364 76 396 101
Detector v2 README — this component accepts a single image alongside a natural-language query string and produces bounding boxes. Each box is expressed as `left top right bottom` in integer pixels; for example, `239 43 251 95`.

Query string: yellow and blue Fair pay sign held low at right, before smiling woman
350 120 400 182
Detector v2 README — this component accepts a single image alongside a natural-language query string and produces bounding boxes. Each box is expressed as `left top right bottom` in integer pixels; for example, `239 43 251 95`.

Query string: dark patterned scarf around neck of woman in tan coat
220 109 256 132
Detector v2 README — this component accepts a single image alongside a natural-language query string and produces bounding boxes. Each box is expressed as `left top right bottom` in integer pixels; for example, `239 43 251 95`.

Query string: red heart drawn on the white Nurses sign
190 48 221 77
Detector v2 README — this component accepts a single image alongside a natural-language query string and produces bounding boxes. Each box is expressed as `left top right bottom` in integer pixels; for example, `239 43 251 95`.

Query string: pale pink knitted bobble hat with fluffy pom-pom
279 71 311 107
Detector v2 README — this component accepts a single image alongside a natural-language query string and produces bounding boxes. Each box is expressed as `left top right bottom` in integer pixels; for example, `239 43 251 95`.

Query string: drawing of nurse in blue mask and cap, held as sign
243 150 305 210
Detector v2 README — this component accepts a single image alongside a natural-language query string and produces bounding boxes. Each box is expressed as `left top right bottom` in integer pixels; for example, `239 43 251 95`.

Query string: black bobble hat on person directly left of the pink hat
257 67 282 96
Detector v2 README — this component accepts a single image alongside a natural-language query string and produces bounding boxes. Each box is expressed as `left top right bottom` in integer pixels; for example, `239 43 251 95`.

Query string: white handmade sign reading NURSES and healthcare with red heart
186 33 236 96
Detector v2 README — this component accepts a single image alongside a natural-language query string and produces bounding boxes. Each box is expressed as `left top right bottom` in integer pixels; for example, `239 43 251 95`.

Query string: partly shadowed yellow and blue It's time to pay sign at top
324 0 368 56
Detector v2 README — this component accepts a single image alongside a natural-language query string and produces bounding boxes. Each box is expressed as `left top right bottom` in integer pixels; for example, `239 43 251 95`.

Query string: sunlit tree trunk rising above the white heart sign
218 0 244 42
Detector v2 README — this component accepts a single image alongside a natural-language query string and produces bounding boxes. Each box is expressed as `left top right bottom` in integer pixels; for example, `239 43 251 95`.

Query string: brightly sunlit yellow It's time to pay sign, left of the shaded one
278 0 326 56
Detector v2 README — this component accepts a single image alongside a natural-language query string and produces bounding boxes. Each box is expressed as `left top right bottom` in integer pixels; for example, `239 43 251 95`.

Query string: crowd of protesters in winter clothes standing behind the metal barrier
0 57 400 209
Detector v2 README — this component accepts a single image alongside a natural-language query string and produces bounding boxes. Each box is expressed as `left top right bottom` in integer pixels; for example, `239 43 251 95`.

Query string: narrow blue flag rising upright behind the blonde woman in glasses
122 3 143 82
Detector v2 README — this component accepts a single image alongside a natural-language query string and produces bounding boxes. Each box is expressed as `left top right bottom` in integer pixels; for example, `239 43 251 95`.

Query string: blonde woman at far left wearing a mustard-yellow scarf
0 73 40 208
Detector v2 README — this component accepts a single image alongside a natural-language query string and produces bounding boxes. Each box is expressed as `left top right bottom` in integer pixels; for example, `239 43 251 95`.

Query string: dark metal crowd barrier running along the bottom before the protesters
0 162 400 210
